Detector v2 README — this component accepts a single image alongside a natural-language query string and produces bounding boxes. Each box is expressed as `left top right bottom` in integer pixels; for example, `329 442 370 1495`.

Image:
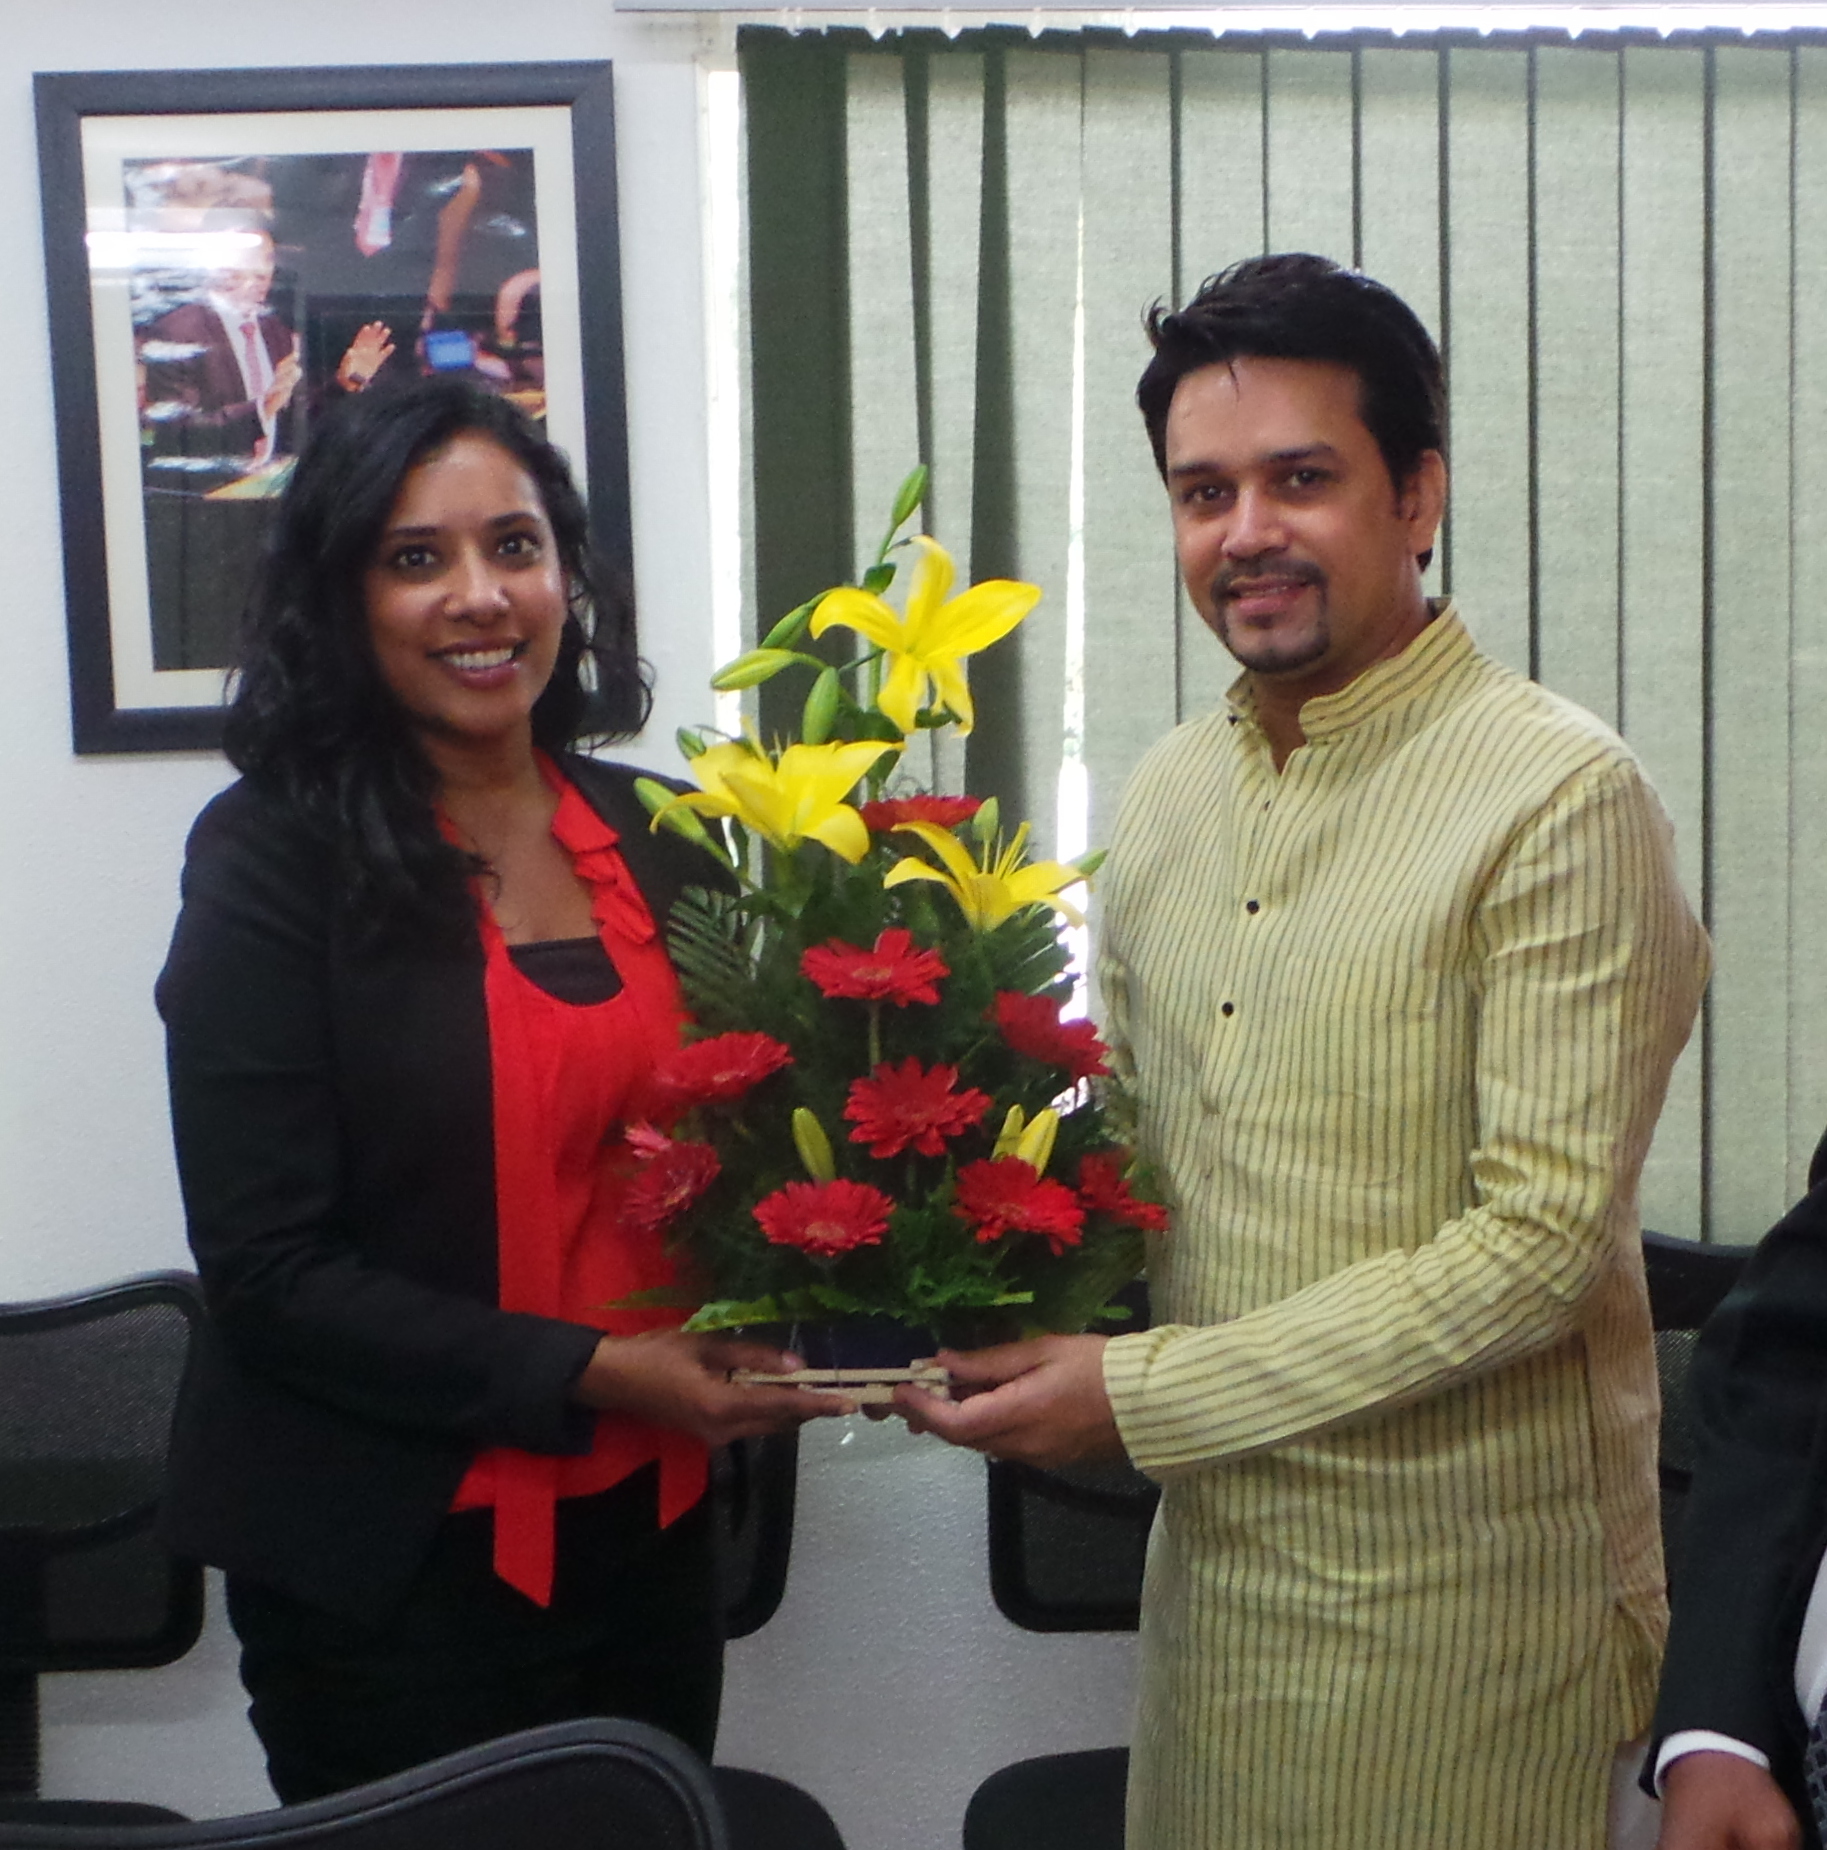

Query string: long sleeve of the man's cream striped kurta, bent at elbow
1104 753 1709 1476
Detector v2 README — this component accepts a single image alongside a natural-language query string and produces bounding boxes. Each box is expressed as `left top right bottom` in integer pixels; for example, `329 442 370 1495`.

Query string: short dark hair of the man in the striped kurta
1135 252 1446 488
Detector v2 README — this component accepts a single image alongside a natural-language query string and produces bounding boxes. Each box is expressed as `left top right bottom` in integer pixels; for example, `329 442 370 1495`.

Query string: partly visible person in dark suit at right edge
1648 1138 1827 1850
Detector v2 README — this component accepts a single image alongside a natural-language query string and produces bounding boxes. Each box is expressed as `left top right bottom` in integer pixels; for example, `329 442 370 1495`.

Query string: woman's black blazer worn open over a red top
157 759 723 1621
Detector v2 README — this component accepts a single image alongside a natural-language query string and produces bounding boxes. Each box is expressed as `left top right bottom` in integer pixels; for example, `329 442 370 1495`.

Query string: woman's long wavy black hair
224 379 651 931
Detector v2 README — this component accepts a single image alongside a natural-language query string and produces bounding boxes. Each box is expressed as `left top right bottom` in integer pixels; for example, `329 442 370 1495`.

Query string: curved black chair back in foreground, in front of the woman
0 1721 729 1850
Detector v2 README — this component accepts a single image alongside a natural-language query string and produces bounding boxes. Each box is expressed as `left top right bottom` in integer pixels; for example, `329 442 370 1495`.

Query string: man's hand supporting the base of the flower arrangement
895 1336 1122 1465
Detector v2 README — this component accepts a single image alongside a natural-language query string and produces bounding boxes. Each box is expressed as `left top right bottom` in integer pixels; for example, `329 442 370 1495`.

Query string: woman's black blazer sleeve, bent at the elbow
157 786 599 1452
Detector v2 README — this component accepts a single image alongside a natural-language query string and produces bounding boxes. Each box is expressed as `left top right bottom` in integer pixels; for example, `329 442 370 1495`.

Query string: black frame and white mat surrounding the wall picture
33 61 632 755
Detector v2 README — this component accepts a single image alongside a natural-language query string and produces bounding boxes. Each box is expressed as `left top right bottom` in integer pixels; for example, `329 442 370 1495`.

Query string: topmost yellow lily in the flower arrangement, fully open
812 533 1041 733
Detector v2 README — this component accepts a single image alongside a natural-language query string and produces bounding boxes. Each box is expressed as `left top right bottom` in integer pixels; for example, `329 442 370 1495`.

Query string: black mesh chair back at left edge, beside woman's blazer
0 1273 203 1796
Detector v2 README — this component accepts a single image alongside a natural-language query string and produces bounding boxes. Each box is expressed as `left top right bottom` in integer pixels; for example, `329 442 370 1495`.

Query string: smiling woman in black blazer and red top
159 379 847 1802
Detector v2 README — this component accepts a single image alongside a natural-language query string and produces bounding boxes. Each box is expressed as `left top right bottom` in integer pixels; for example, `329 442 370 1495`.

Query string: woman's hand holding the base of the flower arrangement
571 1330 856 1445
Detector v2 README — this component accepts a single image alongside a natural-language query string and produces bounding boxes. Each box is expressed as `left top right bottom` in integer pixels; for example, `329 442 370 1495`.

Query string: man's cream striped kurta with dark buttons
1100 609 1709 1850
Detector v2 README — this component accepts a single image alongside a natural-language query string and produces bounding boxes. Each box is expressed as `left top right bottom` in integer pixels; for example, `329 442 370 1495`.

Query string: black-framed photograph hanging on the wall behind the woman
35 63 631 753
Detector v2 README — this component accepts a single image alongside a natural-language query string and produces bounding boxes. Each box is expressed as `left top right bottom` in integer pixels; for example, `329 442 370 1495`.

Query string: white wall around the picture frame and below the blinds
0 0 1132 1850
